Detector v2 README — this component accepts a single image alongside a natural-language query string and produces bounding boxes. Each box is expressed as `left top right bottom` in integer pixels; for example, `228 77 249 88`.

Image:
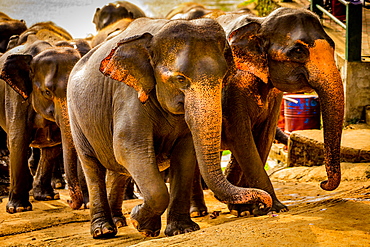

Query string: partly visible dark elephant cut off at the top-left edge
0 12 27 53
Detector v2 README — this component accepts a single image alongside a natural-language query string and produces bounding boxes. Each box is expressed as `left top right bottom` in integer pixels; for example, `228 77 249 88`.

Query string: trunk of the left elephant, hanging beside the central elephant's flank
56 99 84 209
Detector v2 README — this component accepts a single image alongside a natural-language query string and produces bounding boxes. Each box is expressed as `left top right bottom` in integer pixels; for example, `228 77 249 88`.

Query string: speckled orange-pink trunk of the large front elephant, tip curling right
185 83 272 208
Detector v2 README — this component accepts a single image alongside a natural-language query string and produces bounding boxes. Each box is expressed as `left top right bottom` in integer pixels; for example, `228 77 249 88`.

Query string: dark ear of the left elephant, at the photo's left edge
0 54 32 100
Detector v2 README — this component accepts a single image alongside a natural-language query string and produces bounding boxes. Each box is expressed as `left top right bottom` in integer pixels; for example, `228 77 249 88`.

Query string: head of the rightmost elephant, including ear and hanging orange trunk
218 8 344 190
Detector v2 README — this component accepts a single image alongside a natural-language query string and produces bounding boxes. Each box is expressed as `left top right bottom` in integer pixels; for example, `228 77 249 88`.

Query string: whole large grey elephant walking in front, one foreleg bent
66 18 272 238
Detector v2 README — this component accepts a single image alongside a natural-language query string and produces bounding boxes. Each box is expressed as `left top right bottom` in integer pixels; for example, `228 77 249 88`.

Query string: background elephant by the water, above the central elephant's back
93 1 146 31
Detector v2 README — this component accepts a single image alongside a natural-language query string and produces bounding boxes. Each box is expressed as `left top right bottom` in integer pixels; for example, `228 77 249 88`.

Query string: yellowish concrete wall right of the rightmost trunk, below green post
336 55 370 124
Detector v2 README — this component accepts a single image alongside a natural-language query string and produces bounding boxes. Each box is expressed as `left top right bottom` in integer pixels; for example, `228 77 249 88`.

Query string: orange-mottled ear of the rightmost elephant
228 22 268 83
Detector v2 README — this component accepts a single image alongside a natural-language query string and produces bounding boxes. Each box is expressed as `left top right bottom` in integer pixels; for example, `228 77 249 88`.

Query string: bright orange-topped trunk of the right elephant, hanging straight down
308 40 344 190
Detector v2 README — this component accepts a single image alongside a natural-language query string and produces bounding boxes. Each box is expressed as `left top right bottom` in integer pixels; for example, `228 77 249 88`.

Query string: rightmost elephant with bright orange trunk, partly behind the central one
193 8 344 215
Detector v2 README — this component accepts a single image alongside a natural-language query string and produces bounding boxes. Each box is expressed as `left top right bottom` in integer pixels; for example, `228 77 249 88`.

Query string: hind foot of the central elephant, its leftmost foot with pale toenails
91 213 117 238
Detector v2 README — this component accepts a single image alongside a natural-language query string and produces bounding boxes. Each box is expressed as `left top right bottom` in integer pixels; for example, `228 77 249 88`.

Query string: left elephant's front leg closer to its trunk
33 145 62 201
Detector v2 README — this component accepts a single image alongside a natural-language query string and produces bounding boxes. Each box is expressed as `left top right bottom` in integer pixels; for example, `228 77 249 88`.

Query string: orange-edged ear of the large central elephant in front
100 33 155 103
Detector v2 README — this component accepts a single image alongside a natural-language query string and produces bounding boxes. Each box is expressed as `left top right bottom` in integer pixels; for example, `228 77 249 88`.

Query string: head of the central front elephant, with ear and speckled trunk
100 19 271 207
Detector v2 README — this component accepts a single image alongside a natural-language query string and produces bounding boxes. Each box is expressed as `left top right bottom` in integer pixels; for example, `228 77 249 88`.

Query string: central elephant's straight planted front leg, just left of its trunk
165 138 200 236
